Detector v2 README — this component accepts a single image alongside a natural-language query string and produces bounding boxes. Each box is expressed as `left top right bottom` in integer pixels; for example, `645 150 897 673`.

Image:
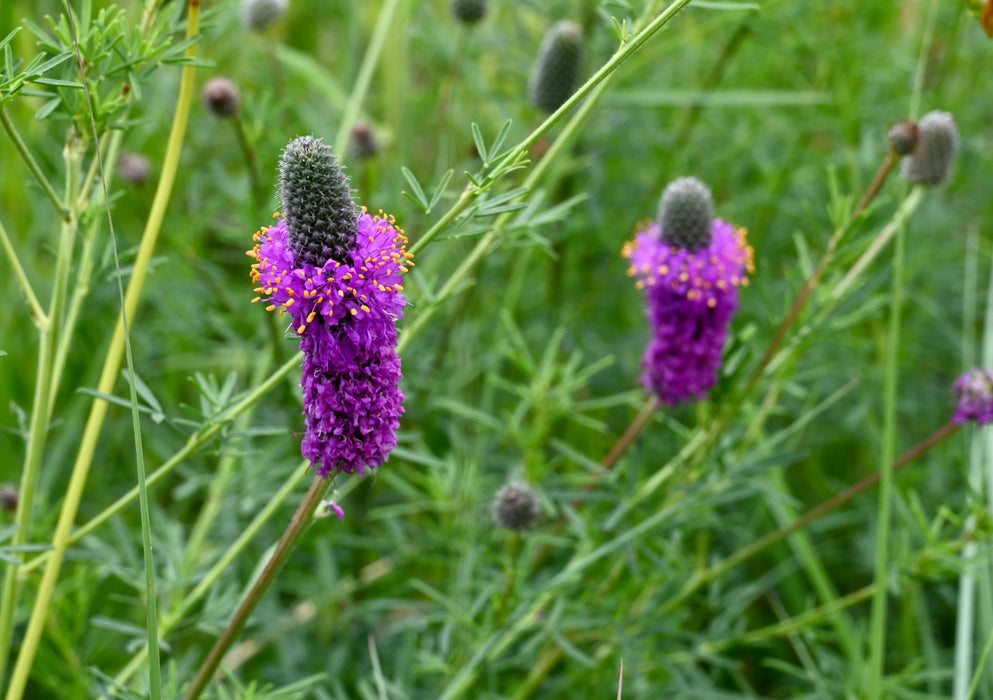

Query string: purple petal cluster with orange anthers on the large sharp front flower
256 212 410 478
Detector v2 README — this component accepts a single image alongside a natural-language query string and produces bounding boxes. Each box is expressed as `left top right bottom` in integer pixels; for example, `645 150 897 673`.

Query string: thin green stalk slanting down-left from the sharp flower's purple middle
21 353 302 572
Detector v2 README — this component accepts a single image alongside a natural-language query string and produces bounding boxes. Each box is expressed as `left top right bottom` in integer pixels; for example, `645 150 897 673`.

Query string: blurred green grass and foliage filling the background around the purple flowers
0 0 993 700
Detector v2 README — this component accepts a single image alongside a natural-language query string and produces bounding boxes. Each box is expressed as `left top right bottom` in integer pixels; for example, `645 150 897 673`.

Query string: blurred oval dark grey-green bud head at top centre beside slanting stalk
528 20 583 113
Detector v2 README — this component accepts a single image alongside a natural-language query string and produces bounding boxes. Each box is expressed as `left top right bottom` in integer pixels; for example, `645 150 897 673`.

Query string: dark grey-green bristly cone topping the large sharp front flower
279 136 358 267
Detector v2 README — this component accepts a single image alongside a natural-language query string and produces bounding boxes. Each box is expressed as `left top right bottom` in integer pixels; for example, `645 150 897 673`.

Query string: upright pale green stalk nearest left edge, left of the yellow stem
0 134 82 678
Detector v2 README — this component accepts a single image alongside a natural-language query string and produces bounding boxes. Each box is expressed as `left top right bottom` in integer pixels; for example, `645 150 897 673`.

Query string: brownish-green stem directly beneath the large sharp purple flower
184 476 328 700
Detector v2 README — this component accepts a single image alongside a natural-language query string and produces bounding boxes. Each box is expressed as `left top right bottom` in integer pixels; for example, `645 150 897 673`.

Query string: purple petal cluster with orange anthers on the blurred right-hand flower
622 219 754 406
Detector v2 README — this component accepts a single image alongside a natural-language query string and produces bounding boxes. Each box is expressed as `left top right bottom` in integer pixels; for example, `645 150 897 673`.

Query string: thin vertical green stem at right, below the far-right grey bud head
868 189 904 698
